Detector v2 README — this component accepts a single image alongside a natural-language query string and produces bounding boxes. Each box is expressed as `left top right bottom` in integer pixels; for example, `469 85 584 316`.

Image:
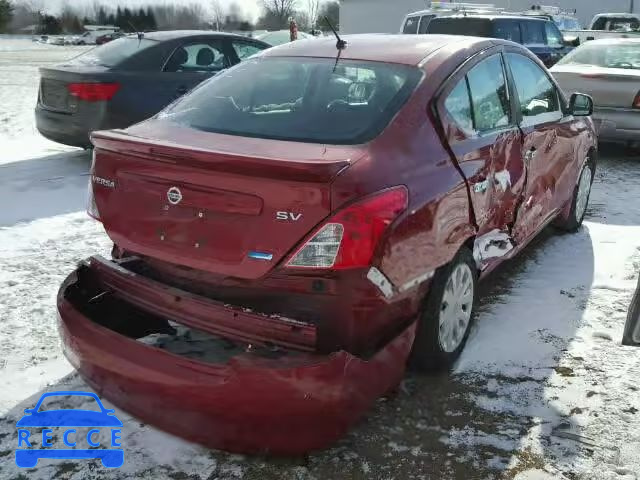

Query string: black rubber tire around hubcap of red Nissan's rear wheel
409 247 478 372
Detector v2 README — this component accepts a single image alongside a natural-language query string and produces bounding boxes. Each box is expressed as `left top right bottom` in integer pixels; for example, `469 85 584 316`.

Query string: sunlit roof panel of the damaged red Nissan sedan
263 34 487 65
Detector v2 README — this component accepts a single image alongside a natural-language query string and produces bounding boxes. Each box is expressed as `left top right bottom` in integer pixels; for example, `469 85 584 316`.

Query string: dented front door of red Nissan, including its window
505 50 575 242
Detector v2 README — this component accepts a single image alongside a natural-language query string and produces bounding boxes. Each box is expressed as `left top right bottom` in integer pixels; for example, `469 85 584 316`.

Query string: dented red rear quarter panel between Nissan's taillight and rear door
332 42 492 291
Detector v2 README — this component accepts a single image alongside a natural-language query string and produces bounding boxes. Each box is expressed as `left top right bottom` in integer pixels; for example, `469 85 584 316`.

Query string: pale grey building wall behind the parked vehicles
340 0 640 33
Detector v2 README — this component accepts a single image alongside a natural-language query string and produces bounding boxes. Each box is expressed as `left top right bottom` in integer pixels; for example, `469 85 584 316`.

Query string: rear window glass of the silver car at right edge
558 43 640 69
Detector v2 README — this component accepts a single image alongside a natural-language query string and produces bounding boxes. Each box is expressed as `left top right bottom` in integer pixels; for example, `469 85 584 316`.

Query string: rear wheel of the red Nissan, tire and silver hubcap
410 248 478 371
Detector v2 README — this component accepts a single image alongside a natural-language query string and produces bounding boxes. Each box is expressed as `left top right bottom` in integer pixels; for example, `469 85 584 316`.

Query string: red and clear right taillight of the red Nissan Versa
286 186 408 269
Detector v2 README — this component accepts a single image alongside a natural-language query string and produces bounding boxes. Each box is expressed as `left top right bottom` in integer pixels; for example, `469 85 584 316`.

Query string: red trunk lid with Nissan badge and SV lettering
92 121 361 279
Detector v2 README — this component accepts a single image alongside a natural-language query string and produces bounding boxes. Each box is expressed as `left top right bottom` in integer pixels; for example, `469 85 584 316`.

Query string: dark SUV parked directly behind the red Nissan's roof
426 15 572 67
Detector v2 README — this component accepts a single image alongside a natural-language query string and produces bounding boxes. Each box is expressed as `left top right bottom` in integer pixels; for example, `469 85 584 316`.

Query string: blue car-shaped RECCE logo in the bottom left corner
16 392 124 468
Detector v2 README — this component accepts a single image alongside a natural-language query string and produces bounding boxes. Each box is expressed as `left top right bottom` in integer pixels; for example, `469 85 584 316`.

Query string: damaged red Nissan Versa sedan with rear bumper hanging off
58 35 597 454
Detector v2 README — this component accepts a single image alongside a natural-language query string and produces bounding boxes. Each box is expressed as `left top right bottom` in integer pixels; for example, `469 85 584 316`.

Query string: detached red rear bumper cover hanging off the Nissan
58 257 415 455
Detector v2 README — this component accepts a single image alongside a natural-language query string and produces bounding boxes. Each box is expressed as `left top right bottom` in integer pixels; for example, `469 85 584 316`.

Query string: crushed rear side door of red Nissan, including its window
438 49 525 263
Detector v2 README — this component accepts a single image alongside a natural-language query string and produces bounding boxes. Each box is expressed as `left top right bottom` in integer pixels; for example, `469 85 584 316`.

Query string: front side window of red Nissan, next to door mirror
507 53 562 125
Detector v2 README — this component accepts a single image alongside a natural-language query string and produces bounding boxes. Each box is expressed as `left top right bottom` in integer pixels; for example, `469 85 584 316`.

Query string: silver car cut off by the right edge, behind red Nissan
551 38 640 144
